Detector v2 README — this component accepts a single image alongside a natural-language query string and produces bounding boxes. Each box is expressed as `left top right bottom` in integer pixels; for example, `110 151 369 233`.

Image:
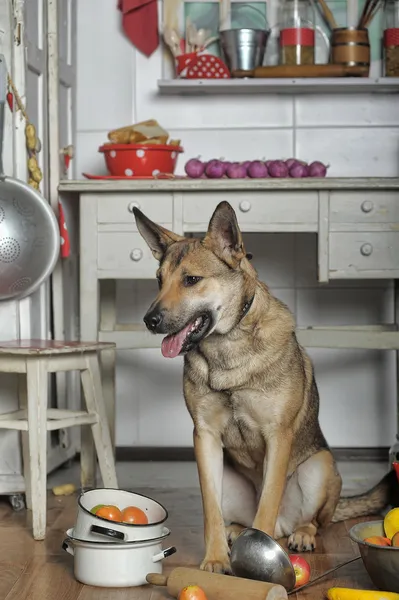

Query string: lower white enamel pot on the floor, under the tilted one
62 527 176 588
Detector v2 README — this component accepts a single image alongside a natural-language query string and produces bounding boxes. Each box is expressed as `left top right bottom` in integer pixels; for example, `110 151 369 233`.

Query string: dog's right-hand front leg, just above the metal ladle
253 431 292 537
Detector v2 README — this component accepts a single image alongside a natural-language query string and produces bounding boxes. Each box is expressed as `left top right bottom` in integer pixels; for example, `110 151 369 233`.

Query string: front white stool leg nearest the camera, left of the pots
26 358 48 540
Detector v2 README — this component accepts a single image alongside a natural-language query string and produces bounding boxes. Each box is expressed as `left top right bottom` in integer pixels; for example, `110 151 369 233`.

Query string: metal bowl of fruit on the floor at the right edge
349 508 399 593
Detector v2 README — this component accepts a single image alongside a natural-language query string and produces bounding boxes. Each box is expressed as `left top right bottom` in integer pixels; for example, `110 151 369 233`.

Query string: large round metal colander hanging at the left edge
0 55 60 300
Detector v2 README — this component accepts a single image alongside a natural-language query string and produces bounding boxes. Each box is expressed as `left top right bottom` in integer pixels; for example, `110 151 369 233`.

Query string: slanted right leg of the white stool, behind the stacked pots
81 353 118 488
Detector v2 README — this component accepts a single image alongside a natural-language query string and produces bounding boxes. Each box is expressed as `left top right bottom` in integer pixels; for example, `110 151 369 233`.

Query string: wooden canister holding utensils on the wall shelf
331 27 370 76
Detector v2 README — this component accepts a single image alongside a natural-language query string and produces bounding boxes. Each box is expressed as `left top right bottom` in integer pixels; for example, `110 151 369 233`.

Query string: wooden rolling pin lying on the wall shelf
231 64 369 79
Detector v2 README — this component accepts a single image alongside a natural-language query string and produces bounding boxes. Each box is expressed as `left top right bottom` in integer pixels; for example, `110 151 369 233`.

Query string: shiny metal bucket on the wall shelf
219 29 270 71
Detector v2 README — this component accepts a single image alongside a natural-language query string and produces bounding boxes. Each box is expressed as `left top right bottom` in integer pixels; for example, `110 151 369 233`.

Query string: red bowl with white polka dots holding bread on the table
98 144 184 177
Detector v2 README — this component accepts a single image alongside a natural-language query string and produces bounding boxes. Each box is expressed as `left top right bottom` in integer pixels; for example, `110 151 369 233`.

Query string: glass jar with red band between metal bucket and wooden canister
280 0 318 66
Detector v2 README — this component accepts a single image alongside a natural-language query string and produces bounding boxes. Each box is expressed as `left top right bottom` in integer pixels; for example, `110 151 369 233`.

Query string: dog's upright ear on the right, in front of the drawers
203 201 246 267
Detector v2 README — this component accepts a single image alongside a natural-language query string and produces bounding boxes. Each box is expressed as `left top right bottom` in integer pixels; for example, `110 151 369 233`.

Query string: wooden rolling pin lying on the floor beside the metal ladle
147 567 288 600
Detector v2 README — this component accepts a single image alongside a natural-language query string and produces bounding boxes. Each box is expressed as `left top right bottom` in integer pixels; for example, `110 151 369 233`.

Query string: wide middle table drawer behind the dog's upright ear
183 191 318 231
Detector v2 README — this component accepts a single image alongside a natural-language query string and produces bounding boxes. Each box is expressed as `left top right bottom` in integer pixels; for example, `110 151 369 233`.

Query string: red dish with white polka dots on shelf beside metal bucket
176 52 230 79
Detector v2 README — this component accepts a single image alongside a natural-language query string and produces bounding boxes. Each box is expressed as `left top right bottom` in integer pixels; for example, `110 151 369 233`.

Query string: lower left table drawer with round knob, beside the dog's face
98 232 158 279
